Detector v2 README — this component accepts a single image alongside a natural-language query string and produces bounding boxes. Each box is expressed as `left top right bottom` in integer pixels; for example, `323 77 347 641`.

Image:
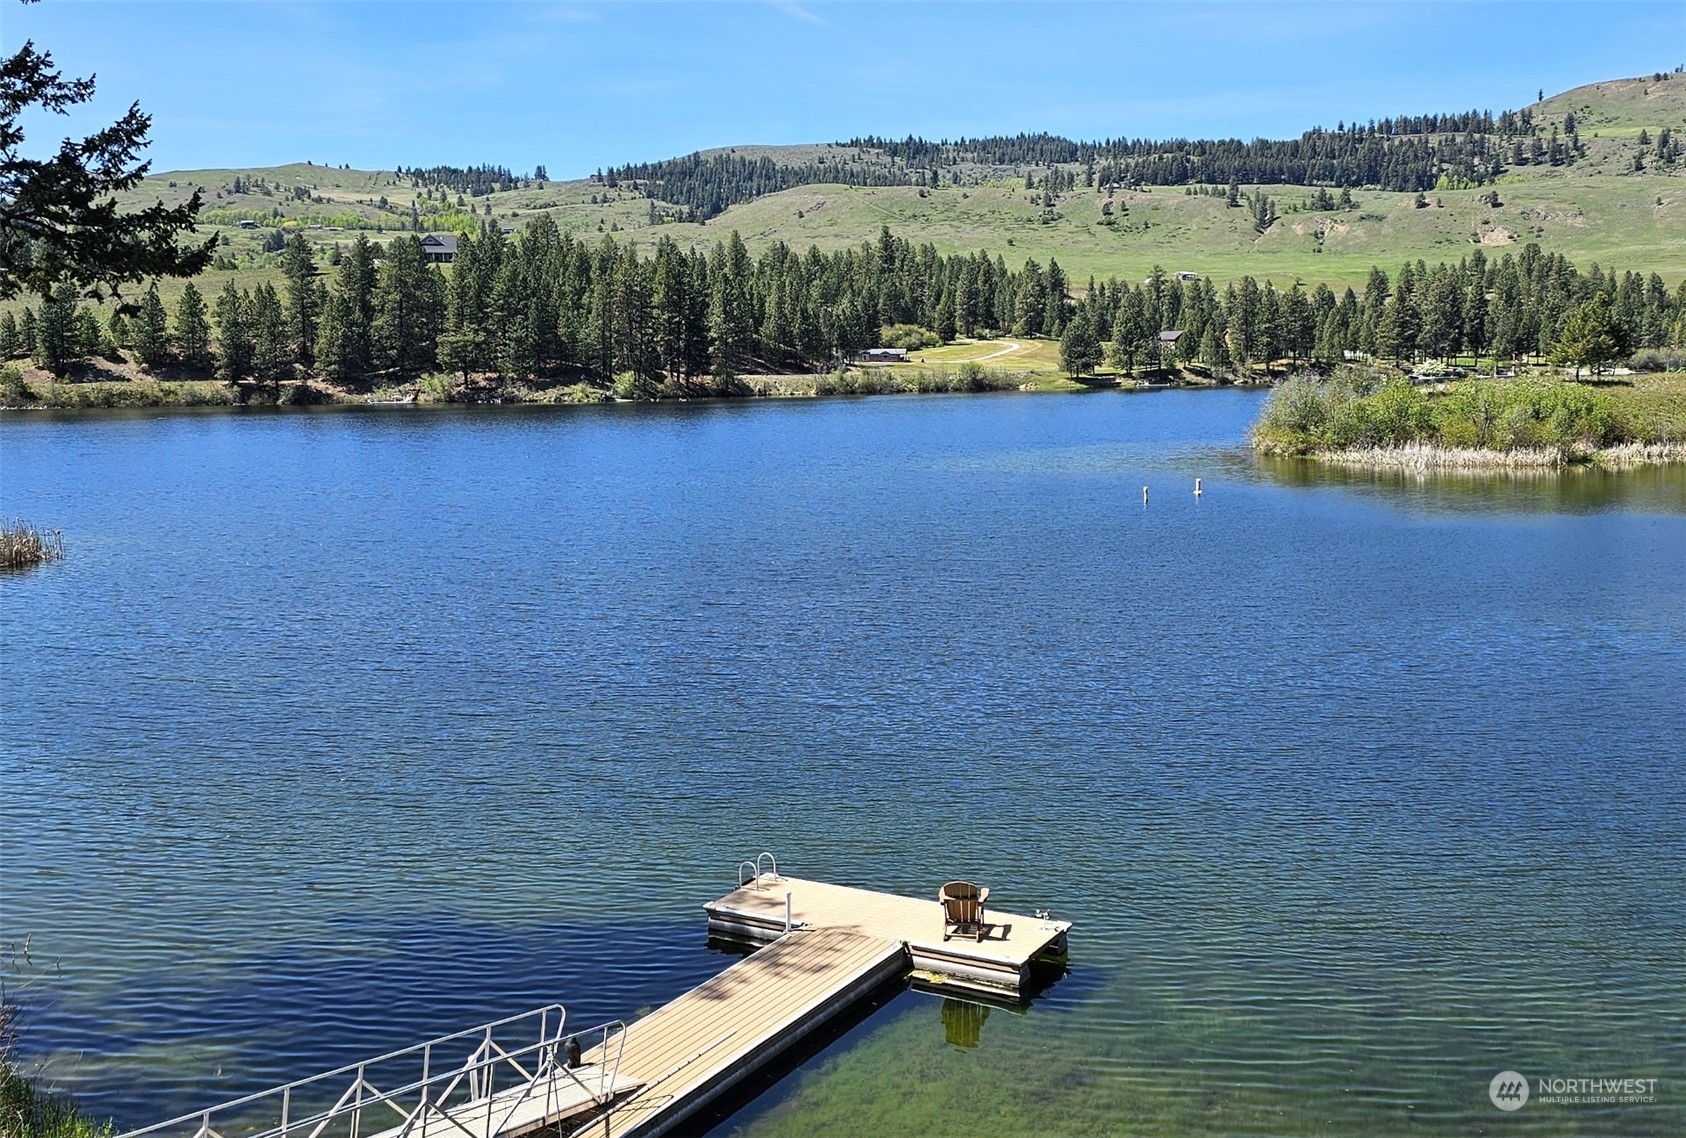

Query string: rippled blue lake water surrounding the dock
0 391 1686 1135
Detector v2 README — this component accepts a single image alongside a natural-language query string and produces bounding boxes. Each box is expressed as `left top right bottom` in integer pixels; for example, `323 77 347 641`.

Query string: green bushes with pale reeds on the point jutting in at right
1253 371 1651 465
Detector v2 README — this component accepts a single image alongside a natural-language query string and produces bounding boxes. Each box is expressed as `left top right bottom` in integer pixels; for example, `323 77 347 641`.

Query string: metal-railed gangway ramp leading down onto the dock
118 1003 627 1138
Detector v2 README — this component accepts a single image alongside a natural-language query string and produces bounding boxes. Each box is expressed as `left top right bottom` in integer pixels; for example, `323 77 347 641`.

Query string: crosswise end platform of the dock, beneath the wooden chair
703 873 1071 996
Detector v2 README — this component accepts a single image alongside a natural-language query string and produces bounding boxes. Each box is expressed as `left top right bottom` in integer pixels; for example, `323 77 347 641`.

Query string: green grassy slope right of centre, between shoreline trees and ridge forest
637 175 1686 285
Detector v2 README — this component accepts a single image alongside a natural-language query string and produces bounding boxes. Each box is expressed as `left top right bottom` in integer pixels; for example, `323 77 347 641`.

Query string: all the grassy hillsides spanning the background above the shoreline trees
6 74 1686 320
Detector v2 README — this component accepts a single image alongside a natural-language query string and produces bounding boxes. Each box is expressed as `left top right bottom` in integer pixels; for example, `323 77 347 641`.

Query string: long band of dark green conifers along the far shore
0 216 1686 406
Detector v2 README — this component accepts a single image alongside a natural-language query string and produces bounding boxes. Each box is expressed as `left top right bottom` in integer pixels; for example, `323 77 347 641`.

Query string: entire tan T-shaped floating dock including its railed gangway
123 853 1071 1138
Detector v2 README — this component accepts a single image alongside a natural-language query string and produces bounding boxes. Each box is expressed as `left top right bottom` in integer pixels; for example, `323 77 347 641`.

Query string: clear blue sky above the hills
0 0 1686 177
